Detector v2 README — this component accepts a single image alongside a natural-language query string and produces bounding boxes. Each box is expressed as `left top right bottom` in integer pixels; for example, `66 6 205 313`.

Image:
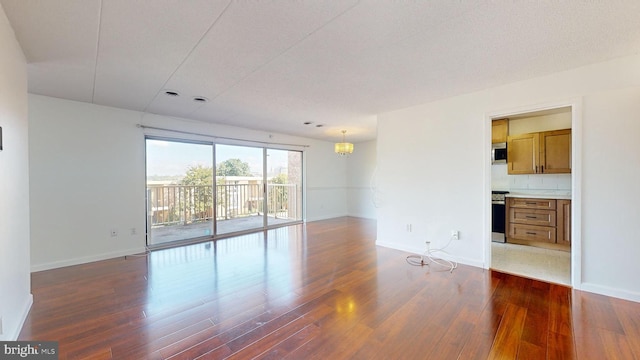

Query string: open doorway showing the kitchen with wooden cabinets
490 106 574 285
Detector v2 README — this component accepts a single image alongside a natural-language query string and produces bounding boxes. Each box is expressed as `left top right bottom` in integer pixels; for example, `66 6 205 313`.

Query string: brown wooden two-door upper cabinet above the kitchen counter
507 129 571 175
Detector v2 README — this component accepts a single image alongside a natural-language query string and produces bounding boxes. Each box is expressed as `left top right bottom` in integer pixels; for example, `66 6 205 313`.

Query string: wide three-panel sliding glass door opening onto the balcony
146 138 303 245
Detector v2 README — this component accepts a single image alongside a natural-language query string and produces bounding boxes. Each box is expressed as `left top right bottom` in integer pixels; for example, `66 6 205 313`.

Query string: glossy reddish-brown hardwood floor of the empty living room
20 218 640 359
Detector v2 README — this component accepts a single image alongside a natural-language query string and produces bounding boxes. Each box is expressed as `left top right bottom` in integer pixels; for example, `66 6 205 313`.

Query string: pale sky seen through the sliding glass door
147 139 288 176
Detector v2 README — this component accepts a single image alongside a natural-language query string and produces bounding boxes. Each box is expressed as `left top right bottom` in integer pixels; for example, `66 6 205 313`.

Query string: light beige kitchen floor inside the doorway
491 242 571 286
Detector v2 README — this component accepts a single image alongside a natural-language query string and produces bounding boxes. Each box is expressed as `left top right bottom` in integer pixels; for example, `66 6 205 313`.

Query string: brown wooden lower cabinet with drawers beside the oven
506 198 571 246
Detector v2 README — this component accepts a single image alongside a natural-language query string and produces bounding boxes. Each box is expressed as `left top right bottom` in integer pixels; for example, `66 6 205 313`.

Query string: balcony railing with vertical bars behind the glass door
147 184 297 227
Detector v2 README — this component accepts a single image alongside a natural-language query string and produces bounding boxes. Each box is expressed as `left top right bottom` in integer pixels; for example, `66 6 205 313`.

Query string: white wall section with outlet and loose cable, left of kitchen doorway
377 91 485 266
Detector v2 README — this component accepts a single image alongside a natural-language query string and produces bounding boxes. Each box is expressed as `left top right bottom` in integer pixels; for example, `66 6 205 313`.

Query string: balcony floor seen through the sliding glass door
149 215 296 245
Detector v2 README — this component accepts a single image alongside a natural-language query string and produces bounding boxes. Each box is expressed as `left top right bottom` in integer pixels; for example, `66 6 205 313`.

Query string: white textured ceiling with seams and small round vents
0 0 640 142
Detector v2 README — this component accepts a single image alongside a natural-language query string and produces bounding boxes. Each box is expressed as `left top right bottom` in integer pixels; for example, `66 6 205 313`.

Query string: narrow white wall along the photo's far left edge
0 5 33 340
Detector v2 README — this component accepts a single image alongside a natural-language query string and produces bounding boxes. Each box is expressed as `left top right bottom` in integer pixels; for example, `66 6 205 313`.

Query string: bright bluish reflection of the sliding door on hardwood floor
146 226 304 315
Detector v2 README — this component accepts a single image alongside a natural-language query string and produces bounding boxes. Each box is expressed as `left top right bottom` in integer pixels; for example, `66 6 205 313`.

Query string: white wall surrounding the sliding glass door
29 95 347 271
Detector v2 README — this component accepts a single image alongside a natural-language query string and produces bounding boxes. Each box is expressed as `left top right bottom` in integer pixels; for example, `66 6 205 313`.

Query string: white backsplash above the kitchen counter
491 164 571 191
